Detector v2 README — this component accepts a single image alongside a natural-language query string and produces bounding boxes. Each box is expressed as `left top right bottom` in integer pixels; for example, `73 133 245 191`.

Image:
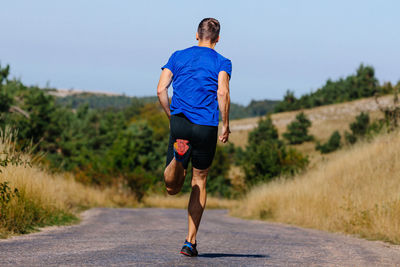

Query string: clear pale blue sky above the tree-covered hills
0 0 400 104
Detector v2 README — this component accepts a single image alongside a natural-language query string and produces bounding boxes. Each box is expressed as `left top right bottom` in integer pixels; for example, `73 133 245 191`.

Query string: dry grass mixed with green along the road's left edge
0 129 137 237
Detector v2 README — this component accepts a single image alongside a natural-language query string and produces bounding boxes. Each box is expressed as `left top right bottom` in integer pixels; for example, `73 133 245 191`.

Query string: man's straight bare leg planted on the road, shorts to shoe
186 168 208 244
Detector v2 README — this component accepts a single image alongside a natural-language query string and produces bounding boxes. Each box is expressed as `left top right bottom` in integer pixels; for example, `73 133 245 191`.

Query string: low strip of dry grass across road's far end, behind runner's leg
142 194 236 209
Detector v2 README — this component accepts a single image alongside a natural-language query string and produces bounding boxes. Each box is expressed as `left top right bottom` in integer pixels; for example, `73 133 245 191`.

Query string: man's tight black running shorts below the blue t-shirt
166 114 218 170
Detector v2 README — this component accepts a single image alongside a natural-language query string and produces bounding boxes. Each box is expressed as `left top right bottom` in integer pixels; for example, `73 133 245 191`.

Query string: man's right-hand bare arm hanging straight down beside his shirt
217 71 231 143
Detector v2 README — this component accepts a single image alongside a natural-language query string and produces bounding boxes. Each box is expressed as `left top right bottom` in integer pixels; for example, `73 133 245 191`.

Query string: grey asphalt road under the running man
0 209 400 266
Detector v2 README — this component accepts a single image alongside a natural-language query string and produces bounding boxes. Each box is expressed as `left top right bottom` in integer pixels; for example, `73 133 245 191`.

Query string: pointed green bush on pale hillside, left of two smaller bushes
283 112 313 145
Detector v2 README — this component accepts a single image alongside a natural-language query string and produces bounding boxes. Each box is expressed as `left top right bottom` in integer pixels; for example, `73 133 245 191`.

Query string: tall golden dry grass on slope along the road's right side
232 132 400 244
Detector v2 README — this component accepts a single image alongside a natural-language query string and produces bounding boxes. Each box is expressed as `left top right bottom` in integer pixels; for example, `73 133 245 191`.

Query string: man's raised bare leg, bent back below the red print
164 158 186 195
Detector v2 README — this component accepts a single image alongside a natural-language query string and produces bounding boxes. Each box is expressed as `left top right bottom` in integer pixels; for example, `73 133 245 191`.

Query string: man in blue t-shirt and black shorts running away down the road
157 18 232 257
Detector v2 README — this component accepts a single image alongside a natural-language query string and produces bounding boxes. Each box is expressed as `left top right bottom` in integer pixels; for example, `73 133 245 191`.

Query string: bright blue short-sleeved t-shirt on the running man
161 46 232 126
